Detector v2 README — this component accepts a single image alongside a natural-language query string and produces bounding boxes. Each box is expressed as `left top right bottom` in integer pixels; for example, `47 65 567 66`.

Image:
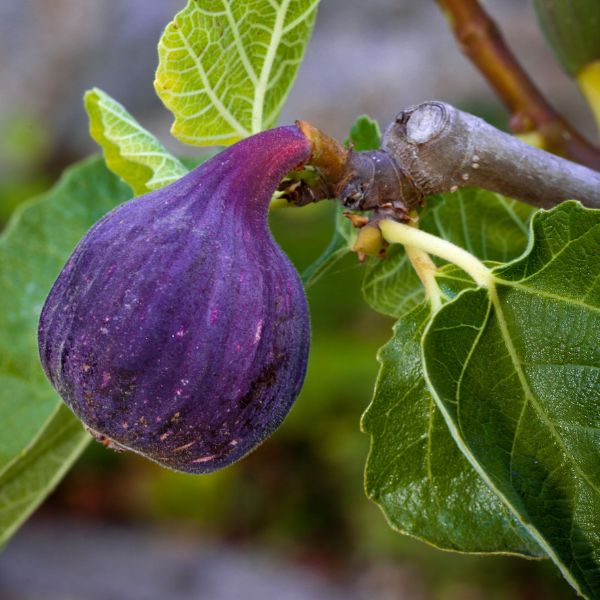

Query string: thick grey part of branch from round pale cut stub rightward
382 102 600 213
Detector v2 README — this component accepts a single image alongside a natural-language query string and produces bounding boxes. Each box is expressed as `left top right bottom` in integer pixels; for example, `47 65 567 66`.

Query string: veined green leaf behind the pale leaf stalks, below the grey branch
363 188 534 317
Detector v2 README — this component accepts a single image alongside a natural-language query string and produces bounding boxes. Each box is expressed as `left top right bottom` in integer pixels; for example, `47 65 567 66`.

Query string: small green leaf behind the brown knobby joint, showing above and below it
302 115 381 288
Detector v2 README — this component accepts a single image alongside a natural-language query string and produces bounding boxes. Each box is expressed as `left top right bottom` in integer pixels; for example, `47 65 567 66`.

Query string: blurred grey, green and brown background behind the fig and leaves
0 0 594 600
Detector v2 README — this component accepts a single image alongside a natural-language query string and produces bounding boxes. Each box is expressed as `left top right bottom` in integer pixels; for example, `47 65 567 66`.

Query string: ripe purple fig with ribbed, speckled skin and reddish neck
39 126 310 473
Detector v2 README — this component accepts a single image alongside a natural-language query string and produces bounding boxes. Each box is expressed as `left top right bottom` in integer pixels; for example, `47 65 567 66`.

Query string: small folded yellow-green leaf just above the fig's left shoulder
84 88 188 195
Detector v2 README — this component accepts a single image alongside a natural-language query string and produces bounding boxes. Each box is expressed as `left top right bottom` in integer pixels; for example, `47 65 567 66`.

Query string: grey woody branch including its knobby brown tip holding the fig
288 101 600 221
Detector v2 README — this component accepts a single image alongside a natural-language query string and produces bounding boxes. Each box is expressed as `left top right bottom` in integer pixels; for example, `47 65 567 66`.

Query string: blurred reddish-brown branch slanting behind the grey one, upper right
436 0 600 170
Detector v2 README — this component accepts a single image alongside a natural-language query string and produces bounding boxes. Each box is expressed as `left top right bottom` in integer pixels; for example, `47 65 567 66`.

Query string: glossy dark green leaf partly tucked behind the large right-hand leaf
362 304 543 556
